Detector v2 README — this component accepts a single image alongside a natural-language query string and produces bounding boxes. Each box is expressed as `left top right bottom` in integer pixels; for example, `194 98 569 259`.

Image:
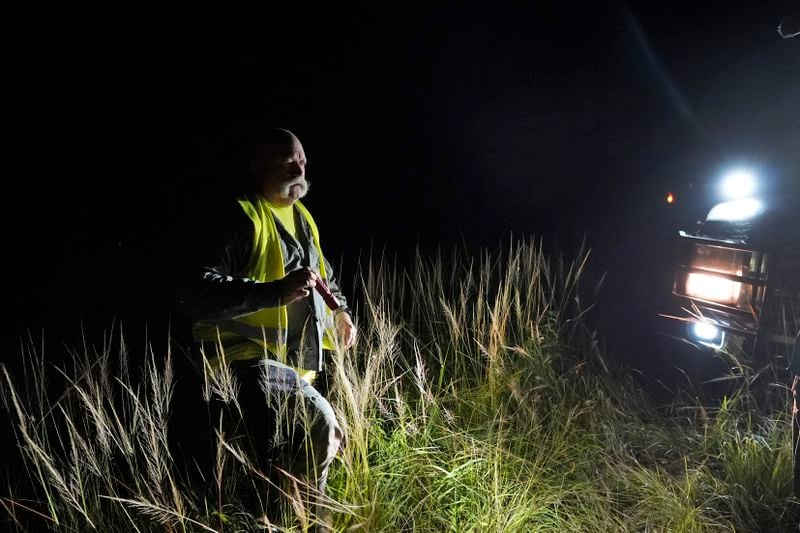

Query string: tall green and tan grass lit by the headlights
2 241 800 532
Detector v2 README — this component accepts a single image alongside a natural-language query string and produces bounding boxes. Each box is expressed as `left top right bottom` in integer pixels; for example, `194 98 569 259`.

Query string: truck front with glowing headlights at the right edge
661 169 800 496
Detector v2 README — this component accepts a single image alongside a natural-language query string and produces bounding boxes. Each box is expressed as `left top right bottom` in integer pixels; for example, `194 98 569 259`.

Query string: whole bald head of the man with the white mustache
250 128 309 207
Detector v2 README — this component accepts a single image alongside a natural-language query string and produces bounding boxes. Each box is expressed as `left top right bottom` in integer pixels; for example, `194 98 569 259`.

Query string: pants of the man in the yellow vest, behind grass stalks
209 360 342 520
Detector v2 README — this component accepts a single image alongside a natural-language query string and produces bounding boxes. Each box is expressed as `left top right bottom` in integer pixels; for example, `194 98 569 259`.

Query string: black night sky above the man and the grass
4 0 800 366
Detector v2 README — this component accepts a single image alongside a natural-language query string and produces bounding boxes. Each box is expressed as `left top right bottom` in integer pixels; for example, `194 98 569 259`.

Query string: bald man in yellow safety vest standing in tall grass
178 129 356 528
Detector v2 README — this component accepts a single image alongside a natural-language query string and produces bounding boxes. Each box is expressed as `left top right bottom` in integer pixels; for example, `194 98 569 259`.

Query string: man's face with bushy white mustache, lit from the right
255 137 309 207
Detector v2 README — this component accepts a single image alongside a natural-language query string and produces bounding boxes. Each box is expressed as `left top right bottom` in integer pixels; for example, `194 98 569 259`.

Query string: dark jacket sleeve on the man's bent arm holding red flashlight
174 205 280 320
